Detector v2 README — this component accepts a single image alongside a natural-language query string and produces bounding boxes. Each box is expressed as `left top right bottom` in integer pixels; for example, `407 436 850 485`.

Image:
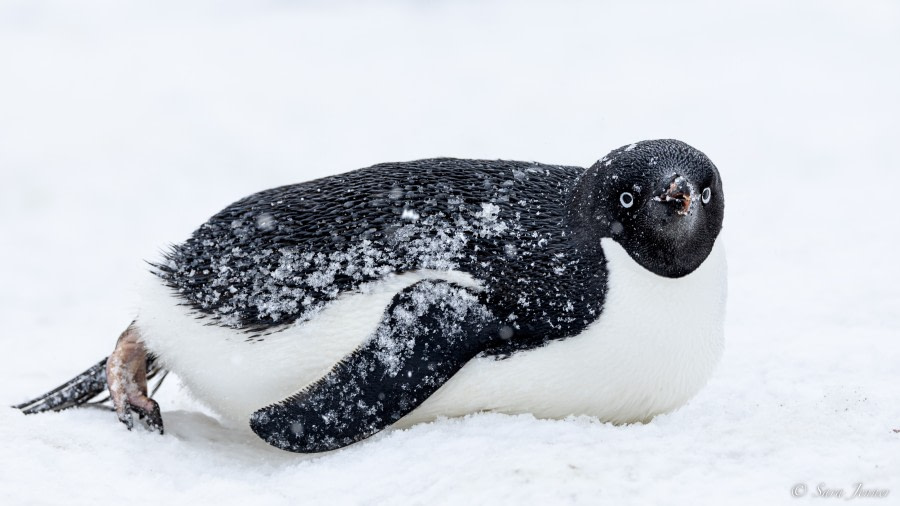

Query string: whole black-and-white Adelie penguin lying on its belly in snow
18 140 726 452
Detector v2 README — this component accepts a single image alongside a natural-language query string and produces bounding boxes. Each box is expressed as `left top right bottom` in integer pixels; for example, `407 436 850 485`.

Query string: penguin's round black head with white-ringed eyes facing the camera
575 139 725 278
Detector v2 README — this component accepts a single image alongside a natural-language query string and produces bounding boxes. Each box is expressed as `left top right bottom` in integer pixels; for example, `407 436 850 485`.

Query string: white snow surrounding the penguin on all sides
0 0 900 504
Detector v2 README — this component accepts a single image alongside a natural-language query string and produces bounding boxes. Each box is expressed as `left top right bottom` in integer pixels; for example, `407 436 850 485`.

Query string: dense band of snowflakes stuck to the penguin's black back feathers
160 190 510 328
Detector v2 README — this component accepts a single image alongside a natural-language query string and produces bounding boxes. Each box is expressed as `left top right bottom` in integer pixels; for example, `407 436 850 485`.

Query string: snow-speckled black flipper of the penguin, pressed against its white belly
250 280 500 453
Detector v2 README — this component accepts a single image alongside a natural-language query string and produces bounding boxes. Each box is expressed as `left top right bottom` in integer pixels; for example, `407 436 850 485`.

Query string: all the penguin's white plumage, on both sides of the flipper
137 239 726 426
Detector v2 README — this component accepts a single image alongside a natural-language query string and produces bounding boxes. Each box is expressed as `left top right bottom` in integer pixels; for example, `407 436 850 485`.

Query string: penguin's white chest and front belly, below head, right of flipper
397 238 727 426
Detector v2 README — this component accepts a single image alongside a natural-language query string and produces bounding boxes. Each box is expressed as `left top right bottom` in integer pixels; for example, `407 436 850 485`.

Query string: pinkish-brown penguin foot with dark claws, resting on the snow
106 323 163 434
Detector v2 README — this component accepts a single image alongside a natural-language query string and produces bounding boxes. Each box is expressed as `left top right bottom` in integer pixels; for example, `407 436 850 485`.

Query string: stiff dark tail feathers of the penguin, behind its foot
13 355 168 415
